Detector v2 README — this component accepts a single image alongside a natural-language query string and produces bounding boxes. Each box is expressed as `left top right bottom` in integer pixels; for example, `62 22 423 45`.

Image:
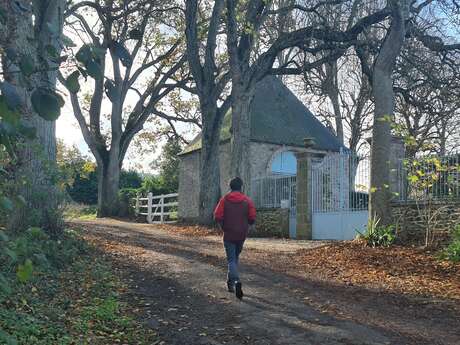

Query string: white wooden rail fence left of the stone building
135 193 179 224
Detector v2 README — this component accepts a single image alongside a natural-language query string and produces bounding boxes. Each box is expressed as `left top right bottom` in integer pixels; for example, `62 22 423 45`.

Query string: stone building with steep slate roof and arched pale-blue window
179 76 346 220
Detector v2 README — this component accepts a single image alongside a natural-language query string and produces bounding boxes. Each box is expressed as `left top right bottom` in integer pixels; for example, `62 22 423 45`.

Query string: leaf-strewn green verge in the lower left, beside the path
0 229 159 345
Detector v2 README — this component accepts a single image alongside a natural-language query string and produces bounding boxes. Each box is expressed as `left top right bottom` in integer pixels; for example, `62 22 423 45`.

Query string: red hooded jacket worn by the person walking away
214 191 256 241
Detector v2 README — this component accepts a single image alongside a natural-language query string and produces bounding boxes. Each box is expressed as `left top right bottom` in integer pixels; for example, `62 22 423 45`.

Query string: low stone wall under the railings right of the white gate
392 201 460 245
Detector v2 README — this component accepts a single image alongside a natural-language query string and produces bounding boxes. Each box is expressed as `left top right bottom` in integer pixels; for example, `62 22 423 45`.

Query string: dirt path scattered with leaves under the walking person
75 220 460 345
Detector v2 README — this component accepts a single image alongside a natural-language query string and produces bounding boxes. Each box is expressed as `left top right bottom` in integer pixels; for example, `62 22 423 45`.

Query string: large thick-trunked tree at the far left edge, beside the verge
0 0 66 233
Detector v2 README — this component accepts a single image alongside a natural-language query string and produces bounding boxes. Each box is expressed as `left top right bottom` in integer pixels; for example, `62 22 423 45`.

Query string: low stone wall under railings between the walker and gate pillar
249 208 289 238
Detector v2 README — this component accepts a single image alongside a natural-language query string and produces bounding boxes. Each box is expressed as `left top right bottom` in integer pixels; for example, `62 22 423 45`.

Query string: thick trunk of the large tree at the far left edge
0 0 66 235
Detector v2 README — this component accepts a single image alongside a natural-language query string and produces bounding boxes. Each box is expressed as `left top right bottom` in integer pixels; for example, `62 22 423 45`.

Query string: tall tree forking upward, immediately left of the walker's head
185 0 230 224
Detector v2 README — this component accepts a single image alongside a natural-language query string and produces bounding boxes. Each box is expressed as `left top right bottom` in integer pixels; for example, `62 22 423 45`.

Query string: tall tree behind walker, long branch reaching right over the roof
226 0 390 188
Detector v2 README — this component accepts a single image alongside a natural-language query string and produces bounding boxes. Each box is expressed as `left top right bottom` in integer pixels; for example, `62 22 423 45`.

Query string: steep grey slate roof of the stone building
182 76 346 154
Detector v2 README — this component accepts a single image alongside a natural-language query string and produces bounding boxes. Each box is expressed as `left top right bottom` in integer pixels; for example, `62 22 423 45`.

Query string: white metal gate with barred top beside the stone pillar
311 153 369 240
